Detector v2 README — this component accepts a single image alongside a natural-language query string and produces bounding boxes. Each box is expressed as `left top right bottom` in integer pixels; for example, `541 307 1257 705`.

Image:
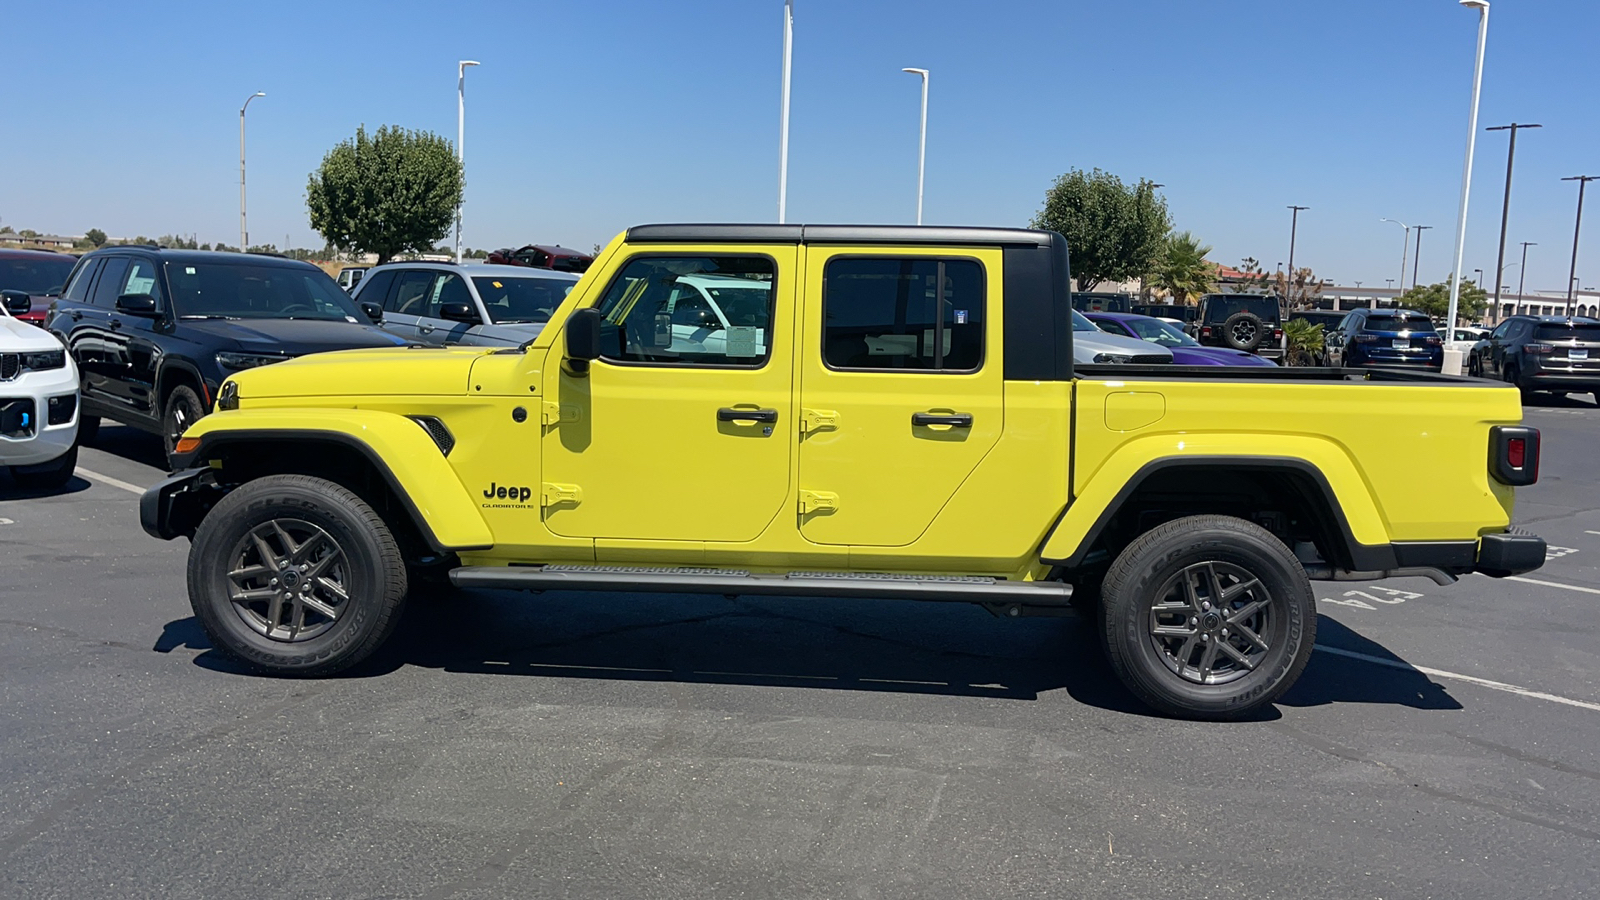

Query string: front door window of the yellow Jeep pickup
598 256 778 368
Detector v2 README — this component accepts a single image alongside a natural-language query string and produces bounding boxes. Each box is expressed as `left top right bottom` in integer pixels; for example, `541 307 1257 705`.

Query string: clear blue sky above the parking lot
0 0 1600 290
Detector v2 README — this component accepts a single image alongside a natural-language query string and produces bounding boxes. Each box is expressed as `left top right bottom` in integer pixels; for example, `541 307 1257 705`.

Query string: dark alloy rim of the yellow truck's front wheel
227 519 350 644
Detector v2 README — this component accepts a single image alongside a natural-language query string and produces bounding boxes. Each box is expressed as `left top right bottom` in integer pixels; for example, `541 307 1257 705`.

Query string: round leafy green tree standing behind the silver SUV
306 125 462 263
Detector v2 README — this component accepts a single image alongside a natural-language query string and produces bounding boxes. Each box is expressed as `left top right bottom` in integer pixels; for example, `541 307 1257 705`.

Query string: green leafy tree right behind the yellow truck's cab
1032 168 1171 290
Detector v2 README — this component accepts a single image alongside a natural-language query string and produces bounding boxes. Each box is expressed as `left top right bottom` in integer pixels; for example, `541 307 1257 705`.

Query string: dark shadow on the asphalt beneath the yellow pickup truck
154 591 1461 721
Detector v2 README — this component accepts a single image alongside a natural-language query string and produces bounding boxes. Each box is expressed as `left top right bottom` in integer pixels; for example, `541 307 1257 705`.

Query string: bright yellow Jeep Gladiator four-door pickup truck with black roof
141 224 1544 719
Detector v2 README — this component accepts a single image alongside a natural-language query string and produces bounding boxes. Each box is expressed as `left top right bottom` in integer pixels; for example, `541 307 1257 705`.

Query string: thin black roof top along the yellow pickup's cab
627 224 1061 247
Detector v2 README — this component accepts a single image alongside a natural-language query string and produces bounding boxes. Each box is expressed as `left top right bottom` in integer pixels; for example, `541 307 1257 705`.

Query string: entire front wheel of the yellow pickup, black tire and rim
189 476 406 676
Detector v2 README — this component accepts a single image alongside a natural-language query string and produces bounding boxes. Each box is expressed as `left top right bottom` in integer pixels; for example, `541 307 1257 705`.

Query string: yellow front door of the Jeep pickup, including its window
539 245 797 541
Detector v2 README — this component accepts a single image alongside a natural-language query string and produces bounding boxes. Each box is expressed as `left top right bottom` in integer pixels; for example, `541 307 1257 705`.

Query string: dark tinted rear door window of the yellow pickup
822 256 985 372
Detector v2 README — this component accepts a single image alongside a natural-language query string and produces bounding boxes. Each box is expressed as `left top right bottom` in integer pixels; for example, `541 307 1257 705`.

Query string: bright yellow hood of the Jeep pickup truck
230 346 493 402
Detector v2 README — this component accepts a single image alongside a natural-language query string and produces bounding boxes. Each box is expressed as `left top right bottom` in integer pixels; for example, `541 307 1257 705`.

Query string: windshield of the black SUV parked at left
166 263 365 322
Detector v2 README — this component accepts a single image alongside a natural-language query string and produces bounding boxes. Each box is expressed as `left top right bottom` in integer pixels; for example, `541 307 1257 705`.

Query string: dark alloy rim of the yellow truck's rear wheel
1149 562 1275 684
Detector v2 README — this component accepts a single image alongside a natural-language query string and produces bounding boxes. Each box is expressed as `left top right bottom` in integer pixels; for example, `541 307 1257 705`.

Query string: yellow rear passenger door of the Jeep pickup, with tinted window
800 247 1005 546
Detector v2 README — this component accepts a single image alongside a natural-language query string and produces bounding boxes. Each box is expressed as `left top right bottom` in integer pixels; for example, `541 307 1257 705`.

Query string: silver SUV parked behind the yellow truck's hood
354 263 579 348
